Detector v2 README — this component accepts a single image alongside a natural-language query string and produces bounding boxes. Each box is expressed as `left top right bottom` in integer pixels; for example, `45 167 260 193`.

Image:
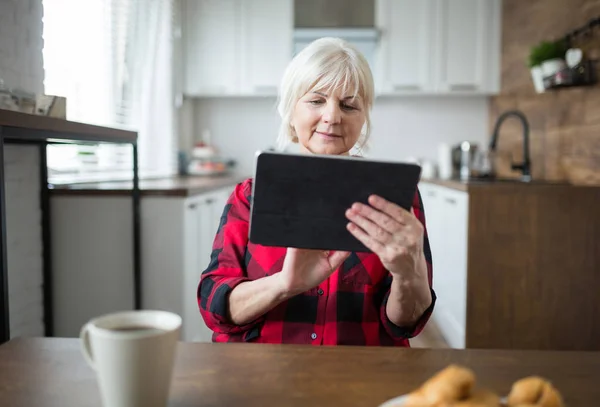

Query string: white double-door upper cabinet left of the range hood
182 0 293 96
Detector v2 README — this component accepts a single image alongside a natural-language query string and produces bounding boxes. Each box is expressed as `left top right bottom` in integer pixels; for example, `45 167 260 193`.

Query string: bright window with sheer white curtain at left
43 0 176 183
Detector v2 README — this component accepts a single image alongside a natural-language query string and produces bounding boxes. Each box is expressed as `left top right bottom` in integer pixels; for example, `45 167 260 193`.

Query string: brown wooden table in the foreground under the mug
0 339 600 407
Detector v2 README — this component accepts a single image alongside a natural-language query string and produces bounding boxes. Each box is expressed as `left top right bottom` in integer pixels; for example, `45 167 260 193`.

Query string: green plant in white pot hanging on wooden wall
528 40 567 93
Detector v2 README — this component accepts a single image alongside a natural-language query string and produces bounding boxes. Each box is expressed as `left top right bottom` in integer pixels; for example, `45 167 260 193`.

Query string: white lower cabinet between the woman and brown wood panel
419 183 469 348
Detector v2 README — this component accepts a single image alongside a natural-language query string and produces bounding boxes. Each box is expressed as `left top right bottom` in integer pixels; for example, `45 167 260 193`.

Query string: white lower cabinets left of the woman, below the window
51 185 234 342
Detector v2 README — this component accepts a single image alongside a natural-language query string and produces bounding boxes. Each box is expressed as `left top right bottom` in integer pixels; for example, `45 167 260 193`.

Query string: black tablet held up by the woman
249 151 421 252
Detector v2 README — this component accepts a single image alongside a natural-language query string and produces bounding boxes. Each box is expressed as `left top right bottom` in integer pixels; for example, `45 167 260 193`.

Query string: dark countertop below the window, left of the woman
50 174 248 197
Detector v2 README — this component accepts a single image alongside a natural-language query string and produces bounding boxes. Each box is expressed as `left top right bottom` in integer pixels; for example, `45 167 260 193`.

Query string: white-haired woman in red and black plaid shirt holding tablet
197 38 435 346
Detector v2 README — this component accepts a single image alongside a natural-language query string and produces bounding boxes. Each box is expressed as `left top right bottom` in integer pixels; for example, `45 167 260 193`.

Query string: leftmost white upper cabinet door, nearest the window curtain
183 0 240 96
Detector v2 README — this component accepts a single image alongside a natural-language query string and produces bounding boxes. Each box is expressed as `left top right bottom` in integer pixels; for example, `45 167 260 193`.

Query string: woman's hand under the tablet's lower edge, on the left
278 247 350 297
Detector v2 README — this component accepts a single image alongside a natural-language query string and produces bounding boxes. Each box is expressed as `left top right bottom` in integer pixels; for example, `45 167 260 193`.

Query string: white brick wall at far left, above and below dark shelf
0 0 44 337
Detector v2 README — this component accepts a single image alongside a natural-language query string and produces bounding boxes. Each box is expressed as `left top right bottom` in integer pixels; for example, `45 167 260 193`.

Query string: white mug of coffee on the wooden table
80 310 181 407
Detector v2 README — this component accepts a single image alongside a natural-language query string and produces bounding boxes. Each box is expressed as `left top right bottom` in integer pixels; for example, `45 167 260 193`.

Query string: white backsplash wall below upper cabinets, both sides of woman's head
190 96 488 175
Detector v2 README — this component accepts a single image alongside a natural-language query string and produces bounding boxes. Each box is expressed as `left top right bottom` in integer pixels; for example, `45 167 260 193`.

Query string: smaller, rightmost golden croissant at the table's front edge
508 376 563 407
